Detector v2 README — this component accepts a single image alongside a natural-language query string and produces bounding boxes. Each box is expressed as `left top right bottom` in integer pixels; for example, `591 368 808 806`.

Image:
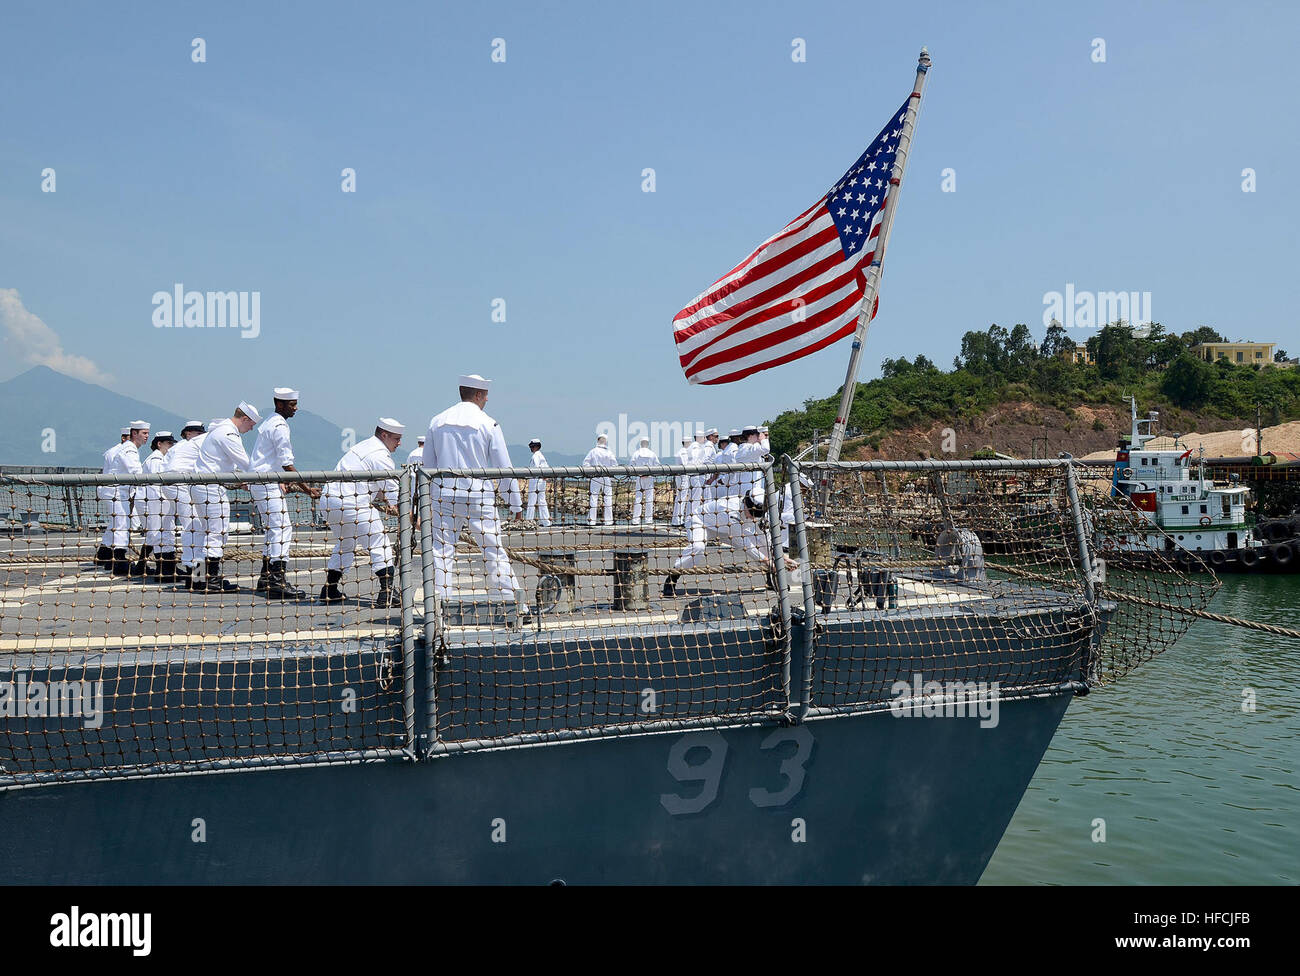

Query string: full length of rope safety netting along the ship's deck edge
0 463 1217 788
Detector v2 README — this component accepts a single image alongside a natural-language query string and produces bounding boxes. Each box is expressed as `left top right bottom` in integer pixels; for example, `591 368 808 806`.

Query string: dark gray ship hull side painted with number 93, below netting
0 693 1071 885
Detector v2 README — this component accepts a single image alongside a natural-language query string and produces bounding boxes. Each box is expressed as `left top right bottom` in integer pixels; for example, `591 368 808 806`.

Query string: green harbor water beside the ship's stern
980 574 1300 885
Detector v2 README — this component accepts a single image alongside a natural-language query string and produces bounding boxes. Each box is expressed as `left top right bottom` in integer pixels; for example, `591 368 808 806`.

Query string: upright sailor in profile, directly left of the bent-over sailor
248 386 312 600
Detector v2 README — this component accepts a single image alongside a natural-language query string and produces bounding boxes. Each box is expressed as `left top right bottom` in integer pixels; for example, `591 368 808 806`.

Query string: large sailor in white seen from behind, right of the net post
424 373 524 600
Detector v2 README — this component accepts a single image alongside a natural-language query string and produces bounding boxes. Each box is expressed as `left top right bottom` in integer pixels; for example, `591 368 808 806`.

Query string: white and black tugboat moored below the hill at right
1095 396 1300 573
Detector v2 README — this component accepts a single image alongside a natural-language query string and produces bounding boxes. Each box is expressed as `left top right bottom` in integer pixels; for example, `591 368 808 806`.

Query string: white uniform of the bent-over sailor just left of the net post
320 437 398 573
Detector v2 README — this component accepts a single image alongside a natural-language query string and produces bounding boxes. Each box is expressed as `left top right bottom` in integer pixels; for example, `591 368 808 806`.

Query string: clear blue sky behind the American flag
0 0 1300 460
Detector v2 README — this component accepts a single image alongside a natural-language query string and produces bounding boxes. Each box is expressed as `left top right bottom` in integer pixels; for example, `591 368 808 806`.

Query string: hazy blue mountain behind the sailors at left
0 366 348 470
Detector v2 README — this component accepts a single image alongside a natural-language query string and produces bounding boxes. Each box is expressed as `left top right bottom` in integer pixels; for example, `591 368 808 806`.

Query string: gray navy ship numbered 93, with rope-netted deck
0 459 1213 885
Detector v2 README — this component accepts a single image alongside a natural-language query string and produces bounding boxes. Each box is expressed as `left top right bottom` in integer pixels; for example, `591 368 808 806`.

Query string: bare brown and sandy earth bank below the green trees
844 400 1300 460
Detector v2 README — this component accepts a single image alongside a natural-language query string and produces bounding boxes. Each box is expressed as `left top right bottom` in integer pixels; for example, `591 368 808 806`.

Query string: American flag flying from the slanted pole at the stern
672 96 910 385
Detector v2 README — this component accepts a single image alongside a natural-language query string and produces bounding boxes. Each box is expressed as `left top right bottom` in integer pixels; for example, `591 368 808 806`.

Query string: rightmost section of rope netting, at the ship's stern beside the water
798 463 1217 708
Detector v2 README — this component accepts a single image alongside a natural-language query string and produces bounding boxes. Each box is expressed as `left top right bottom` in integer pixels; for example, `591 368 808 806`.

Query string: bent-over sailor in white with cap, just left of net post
320 417 406 610
